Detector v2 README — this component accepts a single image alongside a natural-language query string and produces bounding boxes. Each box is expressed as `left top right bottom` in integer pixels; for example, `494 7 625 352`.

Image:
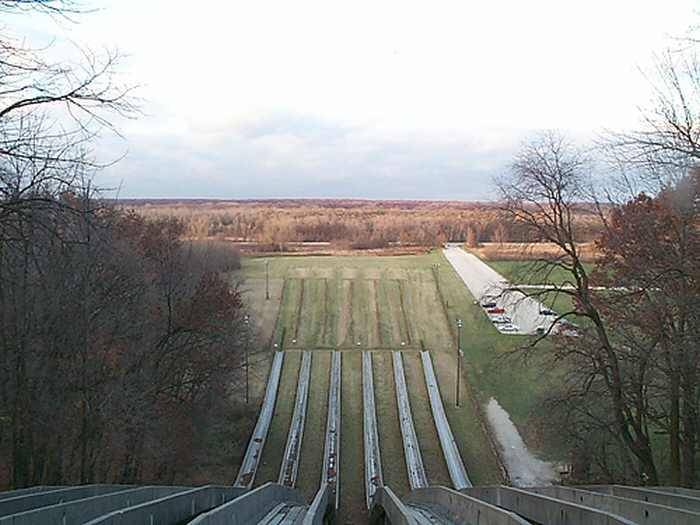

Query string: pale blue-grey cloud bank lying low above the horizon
99 113 522 199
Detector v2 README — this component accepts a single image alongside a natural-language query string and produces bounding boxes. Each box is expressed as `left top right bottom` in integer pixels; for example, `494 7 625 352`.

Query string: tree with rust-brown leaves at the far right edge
601 37 700 486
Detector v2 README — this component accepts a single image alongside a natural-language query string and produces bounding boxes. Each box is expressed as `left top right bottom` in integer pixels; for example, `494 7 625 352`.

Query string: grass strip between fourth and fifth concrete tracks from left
372 352 410 496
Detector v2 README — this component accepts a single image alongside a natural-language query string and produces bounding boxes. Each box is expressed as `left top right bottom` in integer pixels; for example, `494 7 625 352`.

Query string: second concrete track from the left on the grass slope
278 351 311 488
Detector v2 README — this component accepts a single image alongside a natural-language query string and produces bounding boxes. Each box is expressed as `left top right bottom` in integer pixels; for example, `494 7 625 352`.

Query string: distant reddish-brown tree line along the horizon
134 200 602 251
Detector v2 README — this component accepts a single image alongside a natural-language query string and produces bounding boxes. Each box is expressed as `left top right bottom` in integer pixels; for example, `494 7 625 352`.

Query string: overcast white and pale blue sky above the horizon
5 0 700 199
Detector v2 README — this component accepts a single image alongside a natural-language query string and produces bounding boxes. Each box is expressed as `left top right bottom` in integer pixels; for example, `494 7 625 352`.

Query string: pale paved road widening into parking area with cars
443 246 555 334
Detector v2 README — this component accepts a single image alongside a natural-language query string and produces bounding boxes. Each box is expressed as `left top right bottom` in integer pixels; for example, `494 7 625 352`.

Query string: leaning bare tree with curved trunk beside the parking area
497 132 658 483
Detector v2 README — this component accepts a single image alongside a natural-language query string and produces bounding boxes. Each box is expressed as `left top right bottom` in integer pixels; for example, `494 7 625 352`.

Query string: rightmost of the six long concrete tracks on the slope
420 352 472 489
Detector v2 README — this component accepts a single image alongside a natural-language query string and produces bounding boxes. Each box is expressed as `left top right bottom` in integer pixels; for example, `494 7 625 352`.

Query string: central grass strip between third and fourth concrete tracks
338 352 367 524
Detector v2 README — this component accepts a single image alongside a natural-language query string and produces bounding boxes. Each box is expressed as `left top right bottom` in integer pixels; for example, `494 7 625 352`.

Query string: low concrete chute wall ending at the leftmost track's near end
88 485 245 525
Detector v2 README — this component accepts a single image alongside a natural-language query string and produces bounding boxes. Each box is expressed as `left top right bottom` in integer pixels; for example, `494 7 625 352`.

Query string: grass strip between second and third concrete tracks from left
297 351 331 501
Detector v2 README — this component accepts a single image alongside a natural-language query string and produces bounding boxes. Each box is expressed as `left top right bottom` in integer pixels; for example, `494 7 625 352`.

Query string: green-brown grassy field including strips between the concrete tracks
240 251 564 522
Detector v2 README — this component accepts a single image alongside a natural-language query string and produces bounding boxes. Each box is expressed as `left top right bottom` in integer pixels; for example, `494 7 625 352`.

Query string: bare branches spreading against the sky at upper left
0 0 138 239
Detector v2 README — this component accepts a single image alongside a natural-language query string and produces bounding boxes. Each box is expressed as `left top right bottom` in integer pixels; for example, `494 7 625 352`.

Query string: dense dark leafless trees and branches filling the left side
0 0 249 487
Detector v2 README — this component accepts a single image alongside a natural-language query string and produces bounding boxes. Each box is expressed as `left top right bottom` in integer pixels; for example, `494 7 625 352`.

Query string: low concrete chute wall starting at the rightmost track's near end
462 486 634 525
